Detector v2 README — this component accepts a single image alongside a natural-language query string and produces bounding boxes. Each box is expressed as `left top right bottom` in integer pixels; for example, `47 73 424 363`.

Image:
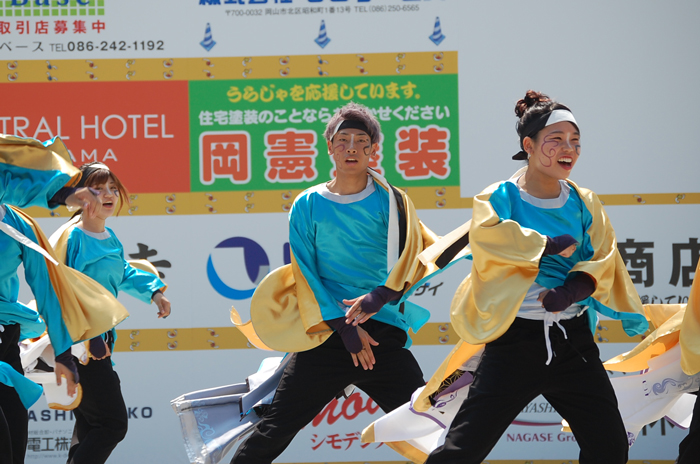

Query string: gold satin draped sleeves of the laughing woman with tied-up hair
451 176 643 344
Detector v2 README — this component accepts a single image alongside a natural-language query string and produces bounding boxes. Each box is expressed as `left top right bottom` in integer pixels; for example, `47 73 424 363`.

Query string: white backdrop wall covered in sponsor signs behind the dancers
0 0 700 463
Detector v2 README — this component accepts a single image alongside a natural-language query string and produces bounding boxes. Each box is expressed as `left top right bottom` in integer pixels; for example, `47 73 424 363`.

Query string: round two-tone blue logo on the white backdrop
207 237 270 300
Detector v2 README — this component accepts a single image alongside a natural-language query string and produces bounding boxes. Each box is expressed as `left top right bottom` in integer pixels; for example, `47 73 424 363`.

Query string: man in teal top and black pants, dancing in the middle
231 103 435 464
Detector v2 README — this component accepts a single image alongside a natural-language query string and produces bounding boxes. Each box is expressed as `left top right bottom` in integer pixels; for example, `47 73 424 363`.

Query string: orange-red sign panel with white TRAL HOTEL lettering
0 82 190 193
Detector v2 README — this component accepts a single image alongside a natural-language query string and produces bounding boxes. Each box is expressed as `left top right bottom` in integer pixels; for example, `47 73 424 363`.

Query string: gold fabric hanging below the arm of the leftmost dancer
13 205 129 342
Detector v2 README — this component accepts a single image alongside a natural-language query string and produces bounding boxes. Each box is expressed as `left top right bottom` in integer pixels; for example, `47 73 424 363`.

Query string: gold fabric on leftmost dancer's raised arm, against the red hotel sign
0 134 81 187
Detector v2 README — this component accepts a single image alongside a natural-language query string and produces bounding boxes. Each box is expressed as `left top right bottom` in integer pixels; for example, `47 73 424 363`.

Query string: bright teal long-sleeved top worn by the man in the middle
289 180 430 343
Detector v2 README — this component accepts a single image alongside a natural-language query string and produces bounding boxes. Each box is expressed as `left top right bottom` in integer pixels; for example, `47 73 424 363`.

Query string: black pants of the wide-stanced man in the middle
231 319 425 464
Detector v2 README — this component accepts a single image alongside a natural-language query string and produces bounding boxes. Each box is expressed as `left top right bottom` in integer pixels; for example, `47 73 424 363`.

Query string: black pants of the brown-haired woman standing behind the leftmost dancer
68 357 128 464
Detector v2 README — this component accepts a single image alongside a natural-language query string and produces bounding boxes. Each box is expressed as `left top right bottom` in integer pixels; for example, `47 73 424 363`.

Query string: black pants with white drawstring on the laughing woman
426 316 628 464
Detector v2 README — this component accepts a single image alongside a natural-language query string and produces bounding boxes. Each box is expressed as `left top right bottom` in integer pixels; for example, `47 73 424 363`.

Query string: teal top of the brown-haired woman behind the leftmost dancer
66 226 165 349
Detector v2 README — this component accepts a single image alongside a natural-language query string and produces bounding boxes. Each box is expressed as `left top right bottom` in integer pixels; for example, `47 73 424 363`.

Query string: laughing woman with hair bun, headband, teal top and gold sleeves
414 90 647 464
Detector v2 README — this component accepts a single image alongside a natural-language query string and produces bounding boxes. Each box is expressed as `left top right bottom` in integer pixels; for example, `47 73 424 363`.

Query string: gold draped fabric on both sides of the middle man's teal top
231 172 437 352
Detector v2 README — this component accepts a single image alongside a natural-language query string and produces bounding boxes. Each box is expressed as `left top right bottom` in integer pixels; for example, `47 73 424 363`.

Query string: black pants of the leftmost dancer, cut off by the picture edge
0 324 29 464
